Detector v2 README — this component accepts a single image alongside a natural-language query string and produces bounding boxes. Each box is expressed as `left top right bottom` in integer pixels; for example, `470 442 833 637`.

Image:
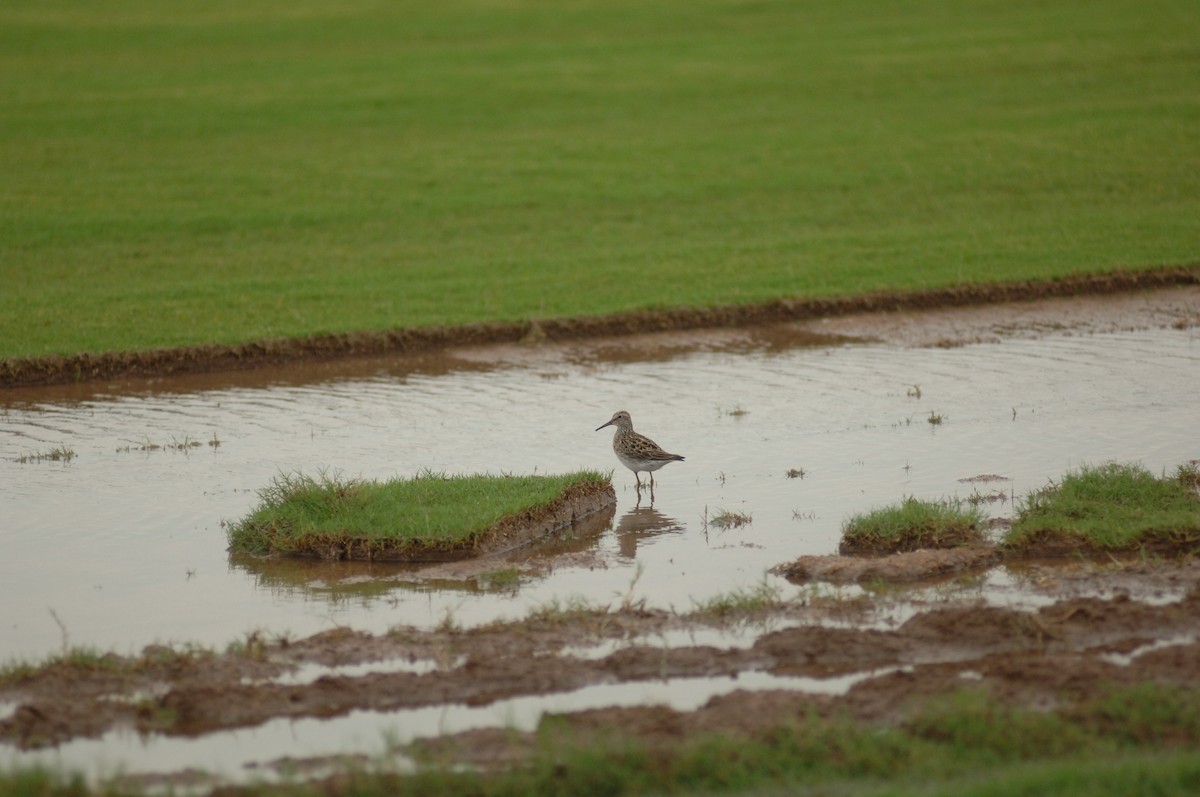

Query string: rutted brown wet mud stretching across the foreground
7 562 1200 765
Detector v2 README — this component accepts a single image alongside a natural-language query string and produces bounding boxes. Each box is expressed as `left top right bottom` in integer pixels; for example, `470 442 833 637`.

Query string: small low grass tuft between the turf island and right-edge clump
841 497 985 553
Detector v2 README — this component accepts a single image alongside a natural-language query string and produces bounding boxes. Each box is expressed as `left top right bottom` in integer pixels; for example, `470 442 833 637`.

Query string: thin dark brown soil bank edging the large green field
0 264 1200 388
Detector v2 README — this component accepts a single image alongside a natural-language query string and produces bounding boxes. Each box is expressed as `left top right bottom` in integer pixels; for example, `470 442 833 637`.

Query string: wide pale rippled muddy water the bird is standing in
0 316 1200 660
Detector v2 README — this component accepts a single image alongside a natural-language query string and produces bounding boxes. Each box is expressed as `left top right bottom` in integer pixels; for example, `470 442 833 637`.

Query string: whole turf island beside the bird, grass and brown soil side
228 471 617 562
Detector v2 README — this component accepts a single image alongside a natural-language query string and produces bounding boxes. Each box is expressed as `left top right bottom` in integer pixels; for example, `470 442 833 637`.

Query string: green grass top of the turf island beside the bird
228 471 608 555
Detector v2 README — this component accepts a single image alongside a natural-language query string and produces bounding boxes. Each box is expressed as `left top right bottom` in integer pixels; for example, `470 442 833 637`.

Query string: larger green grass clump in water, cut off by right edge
1004 462 1200 551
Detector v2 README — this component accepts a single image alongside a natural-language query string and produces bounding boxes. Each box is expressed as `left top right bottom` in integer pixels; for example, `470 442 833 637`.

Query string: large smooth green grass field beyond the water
0 0 1200 358
